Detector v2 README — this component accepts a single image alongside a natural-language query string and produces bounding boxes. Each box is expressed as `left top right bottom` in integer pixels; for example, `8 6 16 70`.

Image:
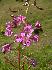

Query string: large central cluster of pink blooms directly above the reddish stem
14 24 39 46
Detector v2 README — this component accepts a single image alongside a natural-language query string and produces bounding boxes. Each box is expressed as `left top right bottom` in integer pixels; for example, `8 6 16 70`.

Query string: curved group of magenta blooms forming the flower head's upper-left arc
4 15 26 36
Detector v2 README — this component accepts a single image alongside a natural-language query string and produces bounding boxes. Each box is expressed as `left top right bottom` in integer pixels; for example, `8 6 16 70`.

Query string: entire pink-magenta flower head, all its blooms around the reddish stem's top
2 15 41 52
